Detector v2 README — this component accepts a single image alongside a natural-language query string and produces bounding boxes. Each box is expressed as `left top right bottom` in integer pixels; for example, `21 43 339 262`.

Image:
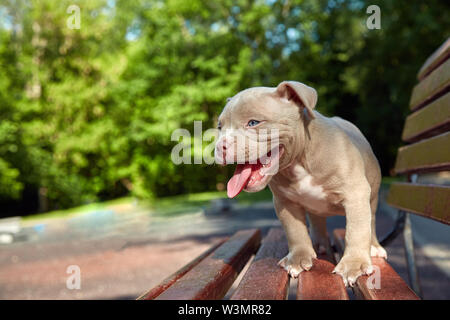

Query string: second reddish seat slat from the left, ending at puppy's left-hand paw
230 228 289 300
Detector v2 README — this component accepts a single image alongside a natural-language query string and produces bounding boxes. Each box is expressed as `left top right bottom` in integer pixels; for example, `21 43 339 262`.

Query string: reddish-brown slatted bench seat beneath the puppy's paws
138 228 418 300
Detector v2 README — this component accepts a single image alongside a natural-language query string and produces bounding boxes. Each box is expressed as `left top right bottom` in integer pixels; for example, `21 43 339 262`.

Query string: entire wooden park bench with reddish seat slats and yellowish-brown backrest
138 40 450 300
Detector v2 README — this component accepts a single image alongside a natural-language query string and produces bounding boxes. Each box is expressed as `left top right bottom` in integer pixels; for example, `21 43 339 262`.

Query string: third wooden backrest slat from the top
402 93 450 142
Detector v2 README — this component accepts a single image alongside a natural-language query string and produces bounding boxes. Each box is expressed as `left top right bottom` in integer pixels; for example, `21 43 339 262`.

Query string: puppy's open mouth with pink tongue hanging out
227 146 284 198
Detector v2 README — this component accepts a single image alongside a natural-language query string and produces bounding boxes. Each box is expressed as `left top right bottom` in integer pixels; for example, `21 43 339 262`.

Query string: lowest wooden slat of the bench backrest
387 182 450 224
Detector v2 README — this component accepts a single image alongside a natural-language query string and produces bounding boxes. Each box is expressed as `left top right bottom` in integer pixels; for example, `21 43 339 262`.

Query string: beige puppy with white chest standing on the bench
215 81 387 286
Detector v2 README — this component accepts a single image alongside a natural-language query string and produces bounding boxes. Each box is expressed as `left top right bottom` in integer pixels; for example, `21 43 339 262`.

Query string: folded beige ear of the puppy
277 81 317 119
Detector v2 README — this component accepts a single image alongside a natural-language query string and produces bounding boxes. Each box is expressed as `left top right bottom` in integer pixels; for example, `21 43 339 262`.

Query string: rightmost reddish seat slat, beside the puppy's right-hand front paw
333 229 419 300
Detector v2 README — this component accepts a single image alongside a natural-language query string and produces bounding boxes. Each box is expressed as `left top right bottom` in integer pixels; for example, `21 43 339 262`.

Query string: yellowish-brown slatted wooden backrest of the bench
387 38 450 224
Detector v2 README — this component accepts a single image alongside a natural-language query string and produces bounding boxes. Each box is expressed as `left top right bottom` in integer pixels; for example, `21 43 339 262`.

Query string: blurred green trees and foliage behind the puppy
0 0 450 216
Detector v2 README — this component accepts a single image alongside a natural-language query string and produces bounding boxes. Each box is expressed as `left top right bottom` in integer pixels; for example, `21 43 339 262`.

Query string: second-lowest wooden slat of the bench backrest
394 132 450 174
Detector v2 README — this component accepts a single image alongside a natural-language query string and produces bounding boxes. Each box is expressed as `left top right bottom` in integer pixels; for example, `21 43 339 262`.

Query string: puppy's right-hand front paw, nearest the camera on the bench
333 256 374 287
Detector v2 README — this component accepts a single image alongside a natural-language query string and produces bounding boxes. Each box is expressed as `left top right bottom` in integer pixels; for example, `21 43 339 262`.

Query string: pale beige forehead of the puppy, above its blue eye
219 87 275 126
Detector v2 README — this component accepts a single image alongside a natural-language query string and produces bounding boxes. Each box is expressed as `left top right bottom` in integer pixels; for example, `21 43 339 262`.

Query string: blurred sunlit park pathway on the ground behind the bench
0 189 450 299
